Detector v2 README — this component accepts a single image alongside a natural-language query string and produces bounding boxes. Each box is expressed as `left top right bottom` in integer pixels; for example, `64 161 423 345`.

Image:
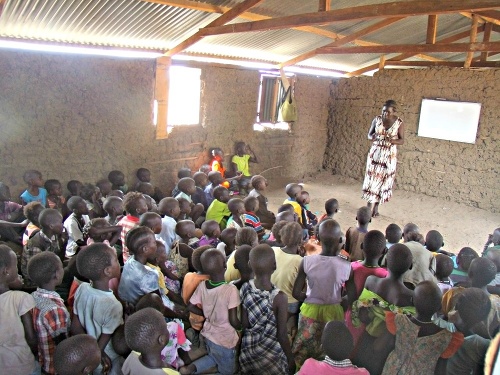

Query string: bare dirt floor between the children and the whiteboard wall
264 171 500 253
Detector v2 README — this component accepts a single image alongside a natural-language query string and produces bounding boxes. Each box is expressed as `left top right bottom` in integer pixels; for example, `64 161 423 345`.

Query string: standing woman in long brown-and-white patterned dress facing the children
363 100 404 217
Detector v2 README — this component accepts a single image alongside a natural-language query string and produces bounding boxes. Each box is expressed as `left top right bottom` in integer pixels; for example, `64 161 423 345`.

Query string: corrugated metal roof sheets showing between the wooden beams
0 0 500 71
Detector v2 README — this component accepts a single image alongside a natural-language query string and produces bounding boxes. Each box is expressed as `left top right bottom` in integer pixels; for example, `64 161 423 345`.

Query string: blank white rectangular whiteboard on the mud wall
417 99 481 143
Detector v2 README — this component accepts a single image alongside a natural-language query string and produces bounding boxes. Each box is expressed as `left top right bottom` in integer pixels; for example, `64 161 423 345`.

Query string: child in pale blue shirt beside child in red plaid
71 243 123 375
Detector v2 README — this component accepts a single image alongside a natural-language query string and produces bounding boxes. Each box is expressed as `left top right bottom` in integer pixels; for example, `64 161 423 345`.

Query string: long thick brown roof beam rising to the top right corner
200 0 500 36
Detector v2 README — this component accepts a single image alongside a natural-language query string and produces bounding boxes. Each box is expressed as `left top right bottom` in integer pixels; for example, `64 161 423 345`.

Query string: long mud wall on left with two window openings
0 50 330 197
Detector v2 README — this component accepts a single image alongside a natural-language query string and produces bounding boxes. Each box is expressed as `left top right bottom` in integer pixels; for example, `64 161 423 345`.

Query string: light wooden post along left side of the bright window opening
155 56 172 139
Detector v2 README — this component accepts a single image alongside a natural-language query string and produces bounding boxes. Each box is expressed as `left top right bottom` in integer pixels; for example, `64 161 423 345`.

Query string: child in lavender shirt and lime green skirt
292 219 352 367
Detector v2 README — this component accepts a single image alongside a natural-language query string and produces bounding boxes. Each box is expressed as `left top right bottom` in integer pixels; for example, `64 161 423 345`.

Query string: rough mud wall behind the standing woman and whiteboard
323 68 500 212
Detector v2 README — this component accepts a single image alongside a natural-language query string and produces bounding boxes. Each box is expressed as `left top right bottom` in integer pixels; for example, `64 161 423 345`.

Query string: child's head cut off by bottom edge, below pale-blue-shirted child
54 334 101 375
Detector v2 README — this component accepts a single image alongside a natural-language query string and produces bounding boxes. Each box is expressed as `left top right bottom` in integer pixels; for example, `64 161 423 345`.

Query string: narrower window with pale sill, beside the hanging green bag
254 73 294 131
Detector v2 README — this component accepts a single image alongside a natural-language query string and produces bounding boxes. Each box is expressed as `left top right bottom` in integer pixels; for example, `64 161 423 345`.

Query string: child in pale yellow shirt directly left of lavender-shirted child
271 222 303 330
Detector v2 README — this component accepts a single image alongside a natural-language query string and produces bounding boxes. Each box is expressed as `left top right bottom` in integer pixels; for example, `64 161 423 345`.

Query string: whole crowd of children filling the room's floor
0 143 500 375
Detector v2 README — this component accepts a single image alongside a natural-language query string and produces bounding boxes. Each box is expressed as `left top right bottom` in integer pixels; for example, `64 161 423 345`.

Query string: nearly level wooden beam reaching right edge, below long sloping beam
317 42 500 55
